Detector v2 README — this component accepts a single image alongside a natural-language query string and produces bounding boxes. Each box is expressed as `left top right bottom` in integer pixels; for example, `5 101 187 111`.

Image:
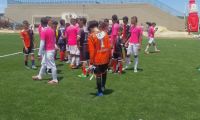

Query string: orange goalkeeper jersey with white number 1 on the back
88 33 111 65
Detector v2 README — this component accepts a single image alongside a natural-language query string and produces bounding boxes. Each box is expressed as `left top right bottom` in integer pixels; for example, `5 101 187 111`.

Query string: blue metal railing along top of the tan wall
8 0 184 16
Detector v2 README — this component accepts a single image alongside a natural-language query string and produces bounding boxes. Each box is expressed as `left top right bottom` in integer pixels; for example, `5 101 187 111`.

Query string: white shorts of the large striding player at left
41 51 56 69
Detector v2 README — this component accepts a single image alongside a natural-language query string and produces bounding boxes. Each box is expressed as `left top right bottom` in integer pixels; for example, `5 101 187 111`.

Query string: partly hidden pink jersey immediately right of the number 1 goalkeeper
111 23 120 44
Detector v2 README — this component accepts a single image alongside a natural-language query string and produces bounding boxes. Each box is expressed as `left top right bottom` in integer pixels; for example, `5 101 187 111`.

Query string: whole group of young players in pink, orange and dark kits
21 15 159 96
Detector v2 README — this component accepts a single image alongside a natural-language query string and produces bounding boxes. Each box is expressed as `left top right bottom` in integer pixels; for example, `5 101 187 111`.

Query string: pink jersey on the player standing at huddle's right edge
129 26 142 44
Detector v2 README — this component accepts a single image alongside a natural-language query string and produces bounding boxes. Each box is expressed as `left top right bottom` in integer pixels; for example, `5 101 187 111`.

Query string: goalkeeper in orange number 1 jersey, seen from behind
88 21 111 96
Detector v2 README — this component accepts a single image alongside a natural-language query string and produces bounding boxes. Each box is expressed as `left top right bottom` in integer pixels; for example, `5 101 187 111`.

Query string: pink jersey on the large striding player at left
41 27 56 51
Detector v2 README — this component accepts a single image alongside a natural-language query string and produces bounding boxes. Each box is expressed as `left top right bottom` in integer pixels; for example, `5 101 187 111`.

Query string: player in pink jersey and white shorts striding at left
32 17 58 84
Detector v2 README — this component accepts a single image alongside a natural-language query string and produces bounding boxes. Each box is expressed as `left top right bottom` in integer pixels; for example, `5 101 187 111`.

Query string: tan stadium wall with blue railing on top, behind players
5 0 185 31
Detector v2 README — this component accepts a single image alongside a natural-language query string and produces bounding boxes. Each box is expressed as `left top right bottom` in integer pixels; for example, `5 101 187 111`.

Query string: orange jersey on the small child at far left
20 30 31 48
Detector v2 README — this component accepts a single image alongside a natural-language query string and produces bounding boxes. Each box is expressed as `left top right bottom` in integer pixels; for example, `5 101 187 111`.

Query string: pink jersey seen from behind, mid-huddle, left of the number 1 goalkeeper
65 25 79 46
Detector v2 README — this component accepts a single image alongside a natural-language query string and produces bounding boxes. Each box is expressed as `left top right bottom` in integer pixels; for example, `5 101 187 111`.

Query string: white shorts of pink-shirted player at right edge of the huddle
127 44 140 55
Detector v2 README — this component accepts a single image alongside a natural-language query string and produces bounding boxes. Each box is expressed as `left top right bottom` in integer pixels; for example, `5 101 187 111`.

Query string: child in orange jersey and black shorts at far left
20 20 36 69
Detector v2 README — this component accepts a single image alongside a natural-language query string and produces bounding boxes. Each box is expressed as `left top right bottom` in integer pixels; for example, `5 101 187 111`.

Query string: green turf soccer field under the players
0 34 200 120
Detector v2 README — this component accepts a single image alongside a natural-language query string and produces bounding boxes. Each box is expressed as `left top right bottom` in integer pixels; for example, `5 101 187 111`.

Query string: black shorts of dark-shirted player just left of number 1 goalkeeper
80 45 90 61
